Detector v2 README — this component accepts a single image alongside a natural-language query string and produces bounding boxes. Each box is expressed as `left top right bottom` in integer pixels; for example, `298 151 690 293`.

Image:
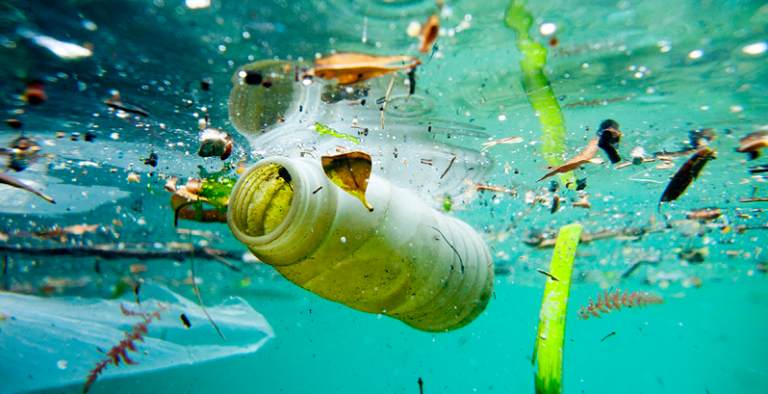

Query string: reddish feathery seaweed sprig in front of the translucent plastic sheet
83 302 168 393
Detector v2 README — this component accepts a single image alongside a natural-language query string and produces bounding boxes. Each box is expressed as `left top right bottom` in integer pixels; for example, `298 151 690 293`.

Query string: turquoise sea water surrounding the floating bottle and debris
0 0 768 393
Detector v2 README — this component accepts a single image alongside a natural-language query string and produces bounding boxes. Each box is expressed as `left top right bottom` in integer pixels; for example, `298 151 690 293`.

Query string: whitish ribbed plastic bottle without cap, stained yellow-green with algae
227 157 493 332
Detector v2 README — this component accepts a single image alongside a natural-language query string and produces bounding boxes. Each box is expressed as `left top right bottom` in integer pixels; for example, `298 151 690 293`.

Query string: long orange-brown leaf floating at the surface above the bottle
306 52 421 85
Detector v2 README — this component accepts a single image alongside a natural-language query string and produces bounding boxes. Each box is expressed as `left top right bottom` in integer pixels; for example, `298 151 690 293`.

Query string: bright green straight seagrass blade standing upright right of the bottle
533 223 582 394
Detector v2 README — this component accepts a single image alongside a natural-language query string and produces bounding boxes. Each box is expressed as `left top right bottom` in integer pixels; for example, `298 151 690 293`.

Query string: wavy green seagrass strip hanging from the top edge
504 0 575 185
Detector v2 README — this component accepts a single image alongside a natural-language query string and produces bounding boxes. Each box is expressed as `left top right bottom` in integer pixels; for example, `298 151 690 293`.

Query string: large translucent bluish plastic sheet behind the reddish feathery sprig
0 285 274 392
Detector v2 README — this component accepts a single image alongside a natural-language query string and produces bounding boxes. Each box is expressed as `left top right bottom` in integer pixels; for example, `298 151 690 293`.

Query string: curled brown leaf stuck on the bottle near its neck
321 151 373 212
